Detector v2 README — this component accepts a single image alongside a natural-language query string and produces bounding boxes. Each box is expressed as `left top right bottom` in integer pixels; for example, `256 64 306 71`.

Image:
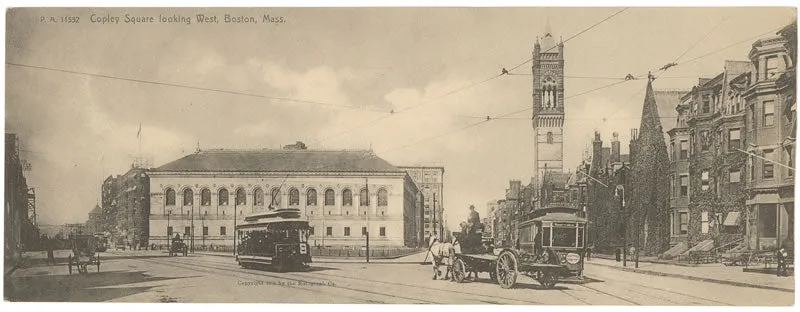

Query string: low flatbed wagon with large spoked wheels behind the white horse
452 234 567 289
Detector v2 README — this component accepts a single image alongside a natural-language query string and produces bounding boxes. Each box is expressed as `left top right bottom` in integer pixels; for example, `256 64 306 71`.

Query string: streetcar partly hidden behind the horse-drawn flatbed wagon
518 207 586 278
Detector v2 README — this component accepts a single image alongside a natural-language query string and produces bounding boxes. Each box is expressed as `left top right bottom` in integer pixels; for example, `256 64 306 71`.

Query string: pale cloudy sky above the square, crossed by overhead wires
5 7 796 227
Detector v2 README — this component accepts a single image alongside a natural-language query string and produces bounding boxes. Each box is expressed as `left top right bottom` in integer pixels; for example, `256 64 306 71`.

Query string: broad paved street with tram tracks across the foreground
6 251 794 306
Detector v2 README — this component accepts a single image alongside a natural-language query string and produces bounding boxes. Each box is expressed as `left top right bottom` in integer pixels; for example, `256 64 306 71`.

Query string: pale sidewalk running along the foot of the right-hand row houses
586 257 794 293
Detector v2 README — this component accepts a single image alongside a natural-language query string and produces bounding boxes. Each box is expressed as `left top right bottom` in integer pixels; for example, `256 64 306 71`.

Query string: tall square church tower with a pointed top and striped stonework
532 22 564 185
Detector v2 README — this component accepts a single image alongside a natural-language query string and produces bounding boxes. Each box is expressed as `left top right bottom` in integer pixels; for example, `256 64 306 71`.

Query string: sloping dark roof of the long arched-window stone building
153 149 404 173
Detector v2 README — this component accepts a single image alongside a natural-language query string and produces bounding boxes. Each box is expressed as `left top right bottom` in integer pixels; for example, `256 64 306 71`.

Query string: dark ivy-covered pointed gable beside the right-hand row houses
627 76 669 254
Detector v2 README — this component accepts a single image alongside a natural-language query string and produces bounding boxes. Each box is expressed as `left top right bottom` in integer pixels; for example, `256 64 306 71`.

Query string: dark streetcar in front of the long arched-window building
234 209 311 272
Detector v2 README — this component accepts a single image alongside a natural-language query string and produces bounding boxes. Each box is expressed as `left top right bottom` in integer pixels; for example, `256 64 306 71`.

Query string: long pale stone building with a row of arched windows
148 149 424 249
